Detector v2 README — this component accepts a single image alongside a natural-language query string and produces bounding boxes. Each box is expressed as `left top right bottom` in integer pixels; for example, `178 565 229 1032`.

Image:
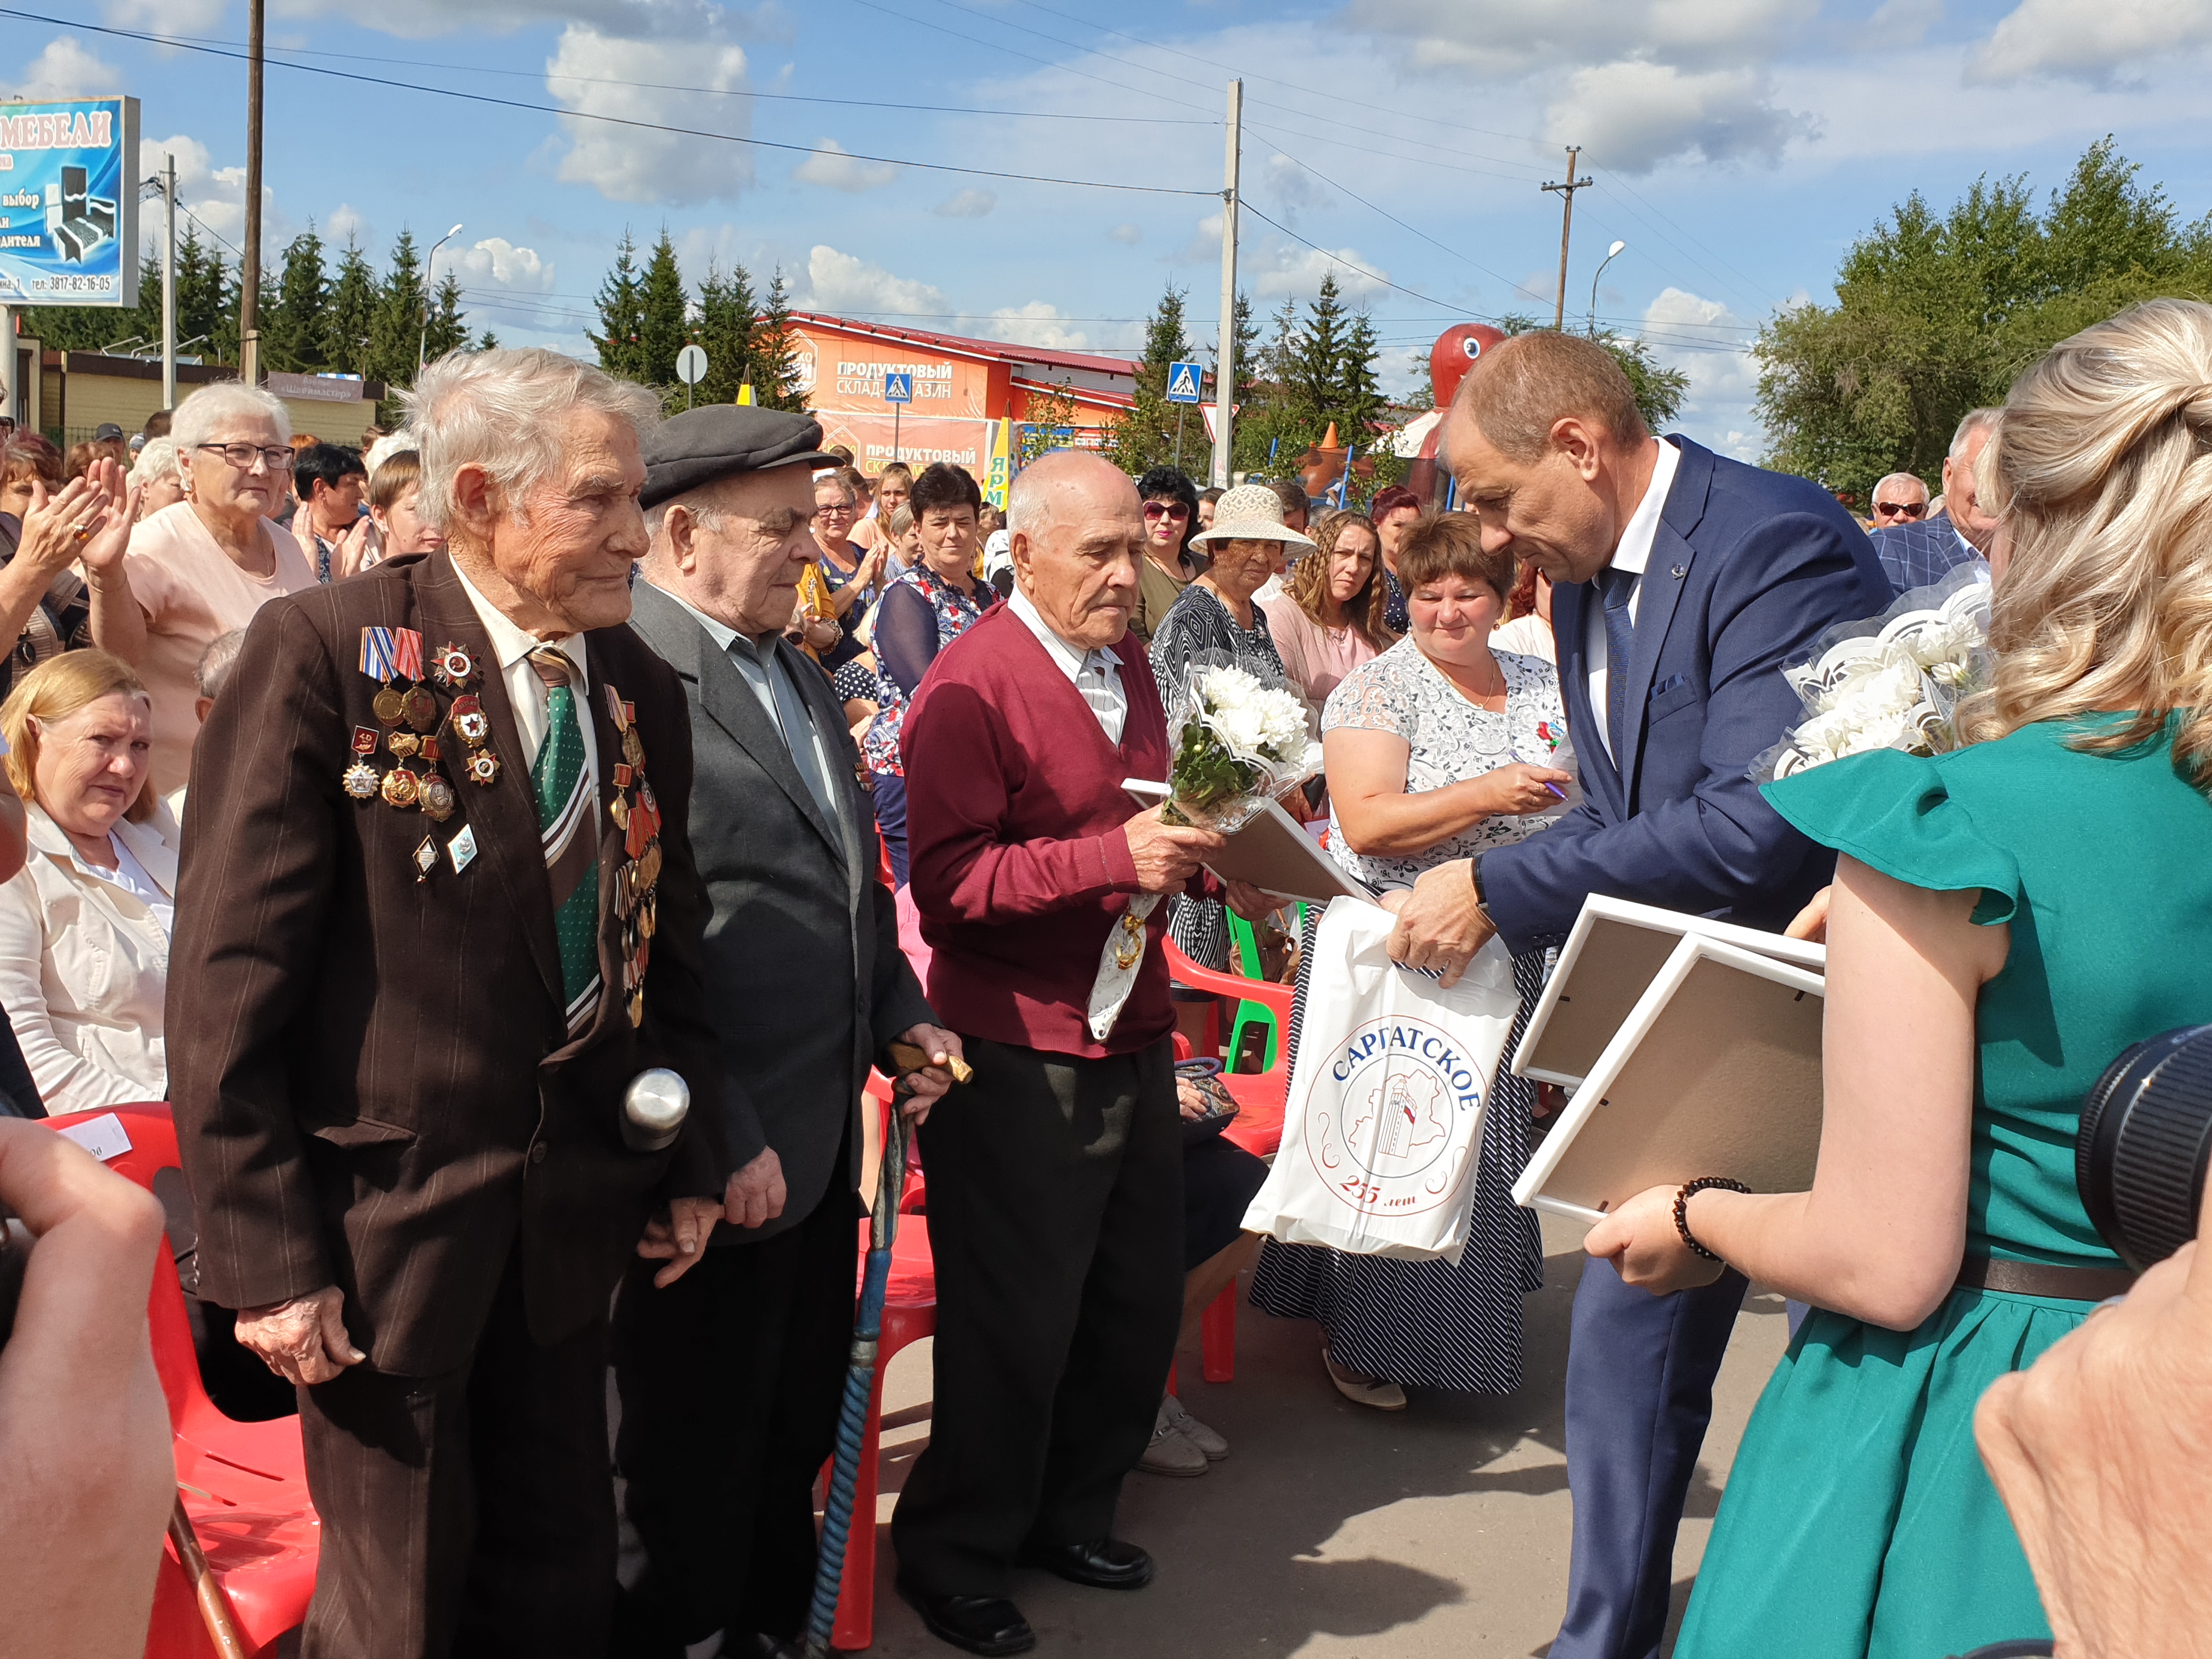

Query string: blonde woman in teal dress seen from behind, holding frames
1588 301 2212 1659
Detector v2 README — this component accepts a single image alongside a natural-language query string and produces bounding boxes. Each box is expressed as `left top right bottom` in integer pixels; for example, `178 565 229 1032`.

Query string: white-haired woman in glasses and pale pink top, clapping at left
93 381 317 794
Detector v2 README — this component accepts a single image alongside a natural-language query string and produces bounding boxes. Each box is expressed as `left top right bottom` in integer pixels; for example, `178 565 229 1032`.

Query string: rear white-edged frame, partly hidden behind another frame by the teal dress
1513 894 1827 1092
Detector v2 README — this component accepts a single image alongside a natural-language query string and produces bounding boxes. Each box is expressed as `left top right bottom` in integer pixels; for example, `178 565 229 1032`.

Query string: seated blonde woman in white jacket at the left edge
0 650 177 1113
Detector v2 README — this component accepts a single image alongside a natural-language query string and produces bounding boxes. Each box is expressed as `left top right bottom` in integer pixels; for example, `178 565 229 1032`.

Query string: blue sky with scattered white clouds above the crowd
13 0 2212 458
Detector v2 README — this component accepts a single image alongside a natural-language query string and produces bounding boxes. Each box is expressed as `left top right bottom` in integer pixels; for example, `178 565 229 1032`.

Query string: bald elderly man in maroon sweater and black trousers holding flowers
891 454 1267 1655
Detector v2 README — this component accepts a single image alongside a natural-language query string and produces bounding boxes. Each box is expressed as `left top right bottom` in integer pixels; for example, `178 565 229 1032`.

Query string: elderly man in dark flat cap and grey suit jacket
615 407 960 1659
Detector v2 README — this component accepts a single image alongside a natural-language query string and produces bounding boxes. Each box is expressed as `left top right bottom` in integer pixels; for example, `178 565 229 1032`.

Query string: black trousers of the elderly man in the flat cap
615 1159 874 1659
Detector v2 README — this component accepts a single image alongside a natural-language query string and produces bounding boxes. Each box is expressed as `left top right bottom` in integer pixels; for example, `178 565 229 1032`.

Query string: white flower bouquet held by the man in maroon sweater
1164 650 1321 834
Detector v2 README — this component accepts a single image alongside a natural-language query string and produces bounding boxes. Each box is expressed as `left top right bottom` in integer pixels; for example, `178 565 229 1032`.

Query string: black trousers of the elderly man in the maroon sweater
891 1037 1183 1595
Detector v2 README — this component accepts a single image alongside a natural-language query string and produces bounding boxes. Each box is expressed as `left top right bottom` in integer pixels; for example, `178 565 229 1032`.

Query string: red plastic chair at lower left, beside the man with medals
49 1104 323 1659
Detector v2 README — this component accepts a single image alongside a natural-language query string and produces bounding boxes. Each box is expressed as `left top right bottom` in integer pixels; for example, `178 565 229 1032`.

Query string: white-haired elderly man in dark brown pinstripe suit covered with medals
168 352 725 1659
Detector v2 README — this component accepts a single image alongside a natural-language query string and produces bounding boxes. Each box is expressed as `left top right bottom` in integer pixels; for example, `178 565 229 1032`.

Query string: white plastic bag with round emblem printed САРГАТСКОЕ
1243 898 1520 1261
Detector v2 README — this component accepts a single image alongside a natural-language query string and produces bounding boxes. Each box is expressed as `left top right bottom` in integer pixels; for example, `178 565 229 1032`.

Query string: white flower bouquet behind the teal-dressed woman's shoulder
1752 560 1989 783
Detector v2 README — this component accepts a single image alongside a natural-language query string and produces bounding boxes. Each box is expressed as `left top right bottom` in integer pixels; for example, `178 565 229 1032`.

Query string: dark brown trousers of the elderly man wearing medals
298 1263 615 1659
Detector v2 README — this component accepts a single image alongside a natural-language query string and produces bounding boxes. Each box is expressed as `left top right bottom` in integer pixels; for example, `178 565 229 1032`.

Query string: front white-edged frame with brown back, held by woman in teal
1513 938 1825 1223
